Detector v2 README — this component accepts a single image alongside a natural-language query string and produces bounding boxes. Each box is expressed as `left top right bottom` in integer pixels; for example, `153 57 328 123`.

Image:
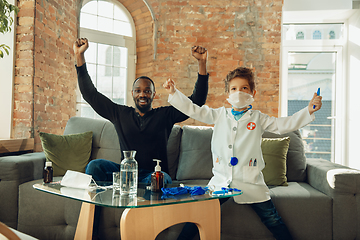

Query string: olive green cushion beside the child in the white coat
261 137 290 186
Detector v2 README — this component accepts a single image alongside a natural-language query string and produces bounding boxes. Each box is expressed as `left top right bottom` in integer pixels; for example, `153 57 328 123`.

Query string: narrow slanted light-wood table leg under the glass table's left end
74 202 95 240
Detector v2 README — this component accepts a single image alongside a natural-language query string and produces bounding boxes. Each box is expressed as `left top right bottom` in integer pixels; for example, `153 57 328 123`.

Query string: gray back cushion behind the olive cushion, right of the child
263 130 306 182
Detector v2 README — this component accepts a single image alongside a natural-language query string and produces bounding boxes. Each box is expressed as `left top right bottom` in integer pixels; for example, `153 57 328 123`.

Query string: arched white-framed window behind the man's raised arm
77 0 136 118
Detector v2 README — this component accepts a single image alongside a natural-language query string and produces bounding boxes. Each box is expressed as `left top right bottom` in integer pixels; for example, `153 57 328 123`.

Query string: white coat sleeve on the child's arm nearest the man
168 89 220 124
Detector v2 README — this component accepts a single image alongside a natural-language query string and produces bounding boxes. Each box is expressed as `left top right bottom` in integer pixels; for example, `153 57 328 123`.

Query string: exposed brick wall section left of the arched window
13 0 77 151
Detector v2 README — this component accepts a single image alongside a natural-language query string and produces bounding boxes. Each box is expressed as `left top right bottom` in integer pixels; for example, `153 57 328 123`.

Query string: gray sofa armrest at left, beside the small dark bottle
0 152 46 228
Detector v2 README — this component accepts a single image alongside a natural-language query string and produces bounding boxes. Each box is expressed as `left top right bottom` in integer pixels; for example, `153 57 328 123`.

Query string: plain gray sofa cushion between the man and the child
176 126 213 180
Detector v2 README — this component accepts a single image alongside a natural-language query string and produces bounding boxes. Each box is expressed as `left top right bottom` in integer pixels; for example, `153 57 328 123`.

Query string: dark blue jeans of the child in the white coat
178 198 292 240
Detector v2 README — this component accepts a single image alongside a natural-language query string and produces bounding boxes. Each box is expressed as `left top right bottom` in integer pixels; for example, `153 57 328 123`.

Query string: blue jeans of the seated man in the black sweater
85 159 172 184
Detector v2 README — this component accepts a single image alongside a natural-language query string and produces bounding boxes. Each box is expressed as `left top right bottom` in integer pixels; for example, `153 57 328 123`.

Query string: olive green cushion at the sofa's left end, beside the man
39 131 93 176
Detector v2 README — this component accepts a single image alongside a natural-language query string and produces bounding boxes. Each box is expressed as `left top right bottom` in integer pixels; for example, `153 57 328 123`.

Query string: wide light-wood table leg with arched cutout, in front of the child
120 199 220 240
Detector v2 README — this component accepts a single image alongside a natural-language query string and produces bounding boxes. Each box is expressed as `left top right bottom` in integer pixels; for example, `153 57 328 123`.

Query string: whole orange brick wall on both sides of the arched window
13 0 282 151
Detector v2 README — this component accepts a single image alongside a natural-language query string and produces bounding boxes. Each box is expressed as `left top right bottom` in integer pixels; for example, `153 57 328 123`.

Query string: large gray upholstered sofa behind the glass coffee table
0 117 360 240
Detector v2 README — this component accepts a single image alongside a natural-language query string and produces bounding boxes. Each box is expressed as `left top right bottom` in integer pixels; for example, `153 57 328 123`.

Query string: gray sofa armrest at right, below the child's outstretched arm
307 159 360 239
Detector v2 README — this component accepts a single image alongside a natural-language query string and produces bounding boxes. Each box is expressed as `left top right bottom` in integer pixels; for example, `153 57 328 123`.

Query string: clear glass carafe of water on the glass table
120 151 138 195
